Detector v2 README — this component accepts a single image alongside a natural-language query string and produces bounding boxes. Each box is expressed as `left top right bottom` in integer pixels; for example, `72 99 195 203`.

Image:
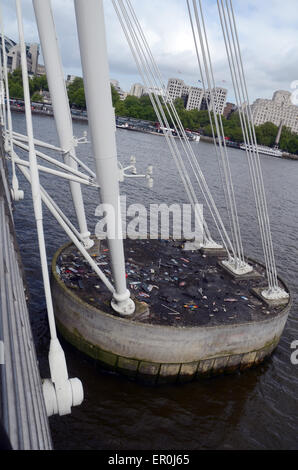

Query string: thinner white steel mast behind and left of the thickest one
33 0 94 248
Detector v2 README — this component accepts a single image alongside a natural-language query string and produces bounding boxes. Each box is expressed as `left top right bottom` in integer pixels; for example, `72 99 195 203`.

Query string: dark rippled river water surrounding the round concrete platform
13 114 298 450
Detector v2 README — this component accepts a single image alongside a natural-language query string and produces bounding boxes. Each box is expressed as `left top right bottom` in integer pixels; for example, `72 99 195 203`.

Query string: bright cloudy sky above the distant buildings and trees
1 0 298 101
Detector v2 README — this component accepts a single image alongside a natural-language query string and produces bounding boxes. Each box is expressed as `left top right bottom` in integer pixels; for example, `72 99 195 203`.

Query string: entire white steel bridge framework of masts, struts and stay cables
0 0 286 414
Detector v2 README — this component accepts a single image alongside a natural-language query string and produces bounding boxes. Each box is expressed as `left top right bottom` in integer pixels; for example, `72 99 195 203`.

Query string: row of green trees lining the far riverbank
9 70 298 155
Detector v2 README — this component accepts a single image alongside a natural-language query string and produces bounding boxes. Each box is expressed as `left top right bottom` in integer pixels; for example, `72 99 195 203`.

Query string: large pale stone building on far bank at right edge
251 90 298 134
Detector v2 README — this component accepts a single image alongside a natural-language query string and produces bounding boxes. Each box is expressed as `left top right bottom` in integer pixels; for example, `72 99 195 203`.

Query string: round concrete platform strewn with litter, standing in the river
52 240 291 383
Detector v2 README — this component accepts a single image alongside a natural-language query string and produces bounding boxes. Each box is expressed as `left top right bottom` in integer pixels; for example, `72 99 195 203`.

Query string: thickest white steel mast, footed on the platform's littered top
74 0 135 316
